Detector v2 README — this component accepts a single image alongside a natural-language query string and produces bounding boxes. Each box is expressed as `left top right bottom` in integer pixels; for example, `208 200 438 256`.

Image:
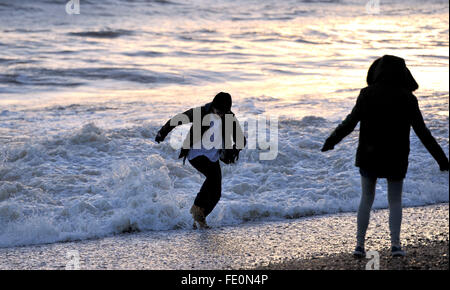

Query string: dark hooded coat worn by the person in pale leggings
324 56 448 179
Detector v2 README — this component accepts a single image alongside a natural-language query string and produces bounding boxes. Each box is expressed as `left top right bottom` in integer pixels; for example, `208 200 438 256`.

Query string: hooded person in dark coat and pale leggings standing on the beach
322 55 449 257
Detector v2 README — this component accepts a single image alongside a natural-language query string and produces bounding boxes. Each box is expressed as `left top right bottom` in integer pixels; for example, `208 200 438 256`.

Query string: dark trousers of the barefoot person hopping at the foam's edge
189 156 222 217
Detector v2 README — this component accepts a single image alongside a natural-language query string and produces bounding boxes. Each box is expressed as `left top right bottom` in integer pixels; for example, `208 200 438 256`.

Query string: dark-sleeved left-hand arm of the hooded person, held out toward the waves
322 93 361 152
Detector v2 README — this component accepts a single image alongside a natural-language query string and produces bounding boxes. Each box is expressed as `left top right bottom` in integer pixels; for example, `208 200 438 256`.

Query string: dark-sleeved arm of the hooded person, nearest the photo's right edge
411 96 449 171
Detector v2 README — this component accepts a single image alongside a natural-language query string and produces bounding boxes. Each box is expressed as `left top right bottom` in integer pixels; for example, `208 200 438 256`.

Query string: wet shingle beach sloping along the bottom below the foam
0 204 449 270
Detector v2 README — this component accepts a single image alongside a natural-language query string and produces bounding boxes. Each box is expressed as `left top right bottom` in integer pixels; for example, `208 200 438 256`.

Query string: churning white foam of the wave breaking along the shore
0 106 448 247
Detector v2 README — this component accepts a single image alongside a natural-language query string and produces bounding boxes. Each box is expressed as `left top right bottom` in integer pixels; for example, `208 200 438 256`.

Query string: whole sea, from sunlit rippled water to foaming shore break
0 0 449 247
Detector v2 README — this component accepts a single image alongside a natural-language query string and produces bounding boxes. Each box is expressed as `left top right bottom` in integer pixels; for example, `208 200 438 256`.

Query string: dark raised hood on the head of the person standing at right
367 55 419 92
